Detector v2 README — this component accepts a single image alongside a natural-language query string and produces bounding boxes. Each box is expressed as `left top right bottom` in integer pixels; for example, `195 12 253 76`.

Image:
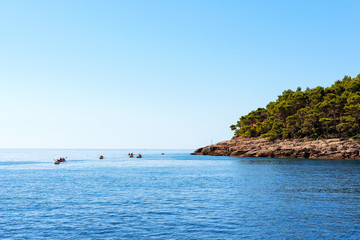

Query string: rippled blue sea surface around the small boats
0 149 360 239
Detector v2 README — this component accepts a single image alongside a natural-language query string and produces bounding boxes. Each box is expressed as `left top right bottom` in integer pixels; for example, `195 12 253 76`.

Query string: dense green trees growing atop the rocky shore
230 74 360 140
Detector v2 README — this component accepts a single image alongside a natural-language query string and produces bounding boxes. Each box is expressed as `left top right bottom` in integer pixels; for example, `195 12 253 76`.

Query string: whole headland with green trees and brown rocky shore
194 74 360 159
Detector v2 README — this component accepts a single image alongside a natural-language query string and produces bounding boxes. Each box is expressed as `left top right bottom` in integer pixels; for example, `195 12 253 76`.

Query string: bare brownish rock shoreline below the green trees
192 137 360 159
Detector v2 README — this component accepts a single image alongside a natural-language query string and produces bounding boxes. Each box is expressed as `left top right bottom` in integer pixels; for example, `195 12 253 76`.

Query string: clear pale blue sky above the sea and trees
0 0 360 149
